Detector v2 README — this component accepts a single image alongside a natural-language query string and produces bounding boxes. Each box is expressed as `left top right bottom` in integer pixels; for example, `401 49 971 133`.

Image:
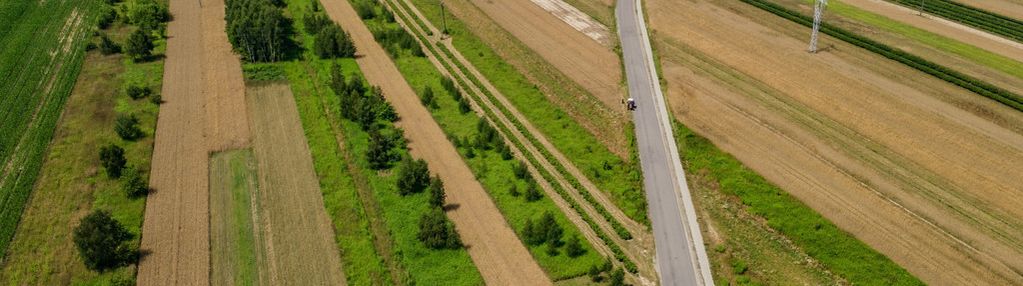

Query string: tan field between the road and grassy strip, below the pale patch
472 0 623 108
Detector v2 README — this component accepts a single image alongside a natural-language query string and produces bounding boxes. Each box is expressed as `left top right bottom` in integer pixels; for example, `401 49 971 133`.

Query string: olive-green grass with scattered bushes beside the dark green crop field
0 26 164 285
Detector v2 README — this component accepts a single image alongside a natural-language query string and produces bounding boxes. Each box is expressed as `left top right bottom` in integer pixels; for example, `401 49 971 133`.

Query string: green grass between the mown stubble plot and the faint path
282 59 394 285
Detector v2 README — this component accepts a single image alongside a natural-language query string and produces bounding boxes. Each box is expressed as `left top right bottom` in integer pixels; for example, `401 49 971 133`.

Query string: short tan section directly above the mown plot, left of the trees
202 0 250 151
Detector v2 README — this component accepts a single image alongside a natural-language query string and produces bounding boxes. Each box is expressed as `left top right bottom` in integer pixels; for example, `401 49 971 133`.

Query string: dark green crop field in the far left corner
0 0 98 251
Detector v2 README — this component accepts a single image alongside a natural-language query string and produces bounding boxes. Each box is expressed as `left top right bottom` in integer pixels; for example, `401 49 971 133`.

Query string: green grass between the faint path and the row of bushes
286 60 483 285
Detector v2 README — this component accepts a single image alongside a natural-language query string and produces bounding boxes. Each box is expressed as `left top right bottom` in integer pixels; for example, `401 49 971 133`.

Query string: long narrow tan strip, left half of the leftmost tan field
137 0 210 285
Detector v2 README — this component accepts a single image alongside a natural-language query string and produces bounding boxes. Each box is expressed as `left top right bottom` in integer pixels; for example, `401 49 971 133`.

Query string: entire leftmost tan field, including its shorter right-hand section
137 0 250 285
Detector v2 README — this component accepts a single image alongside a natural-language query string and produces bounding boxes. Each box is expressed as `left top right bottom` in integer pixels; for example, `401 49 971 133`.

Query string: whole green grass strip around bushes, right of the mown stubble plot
276 0 483 285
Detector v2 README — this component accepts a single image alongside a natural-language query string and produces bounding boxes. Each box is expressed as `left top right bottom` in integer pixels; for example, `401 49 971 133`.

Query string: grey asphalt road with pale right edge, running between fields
615 0 714 285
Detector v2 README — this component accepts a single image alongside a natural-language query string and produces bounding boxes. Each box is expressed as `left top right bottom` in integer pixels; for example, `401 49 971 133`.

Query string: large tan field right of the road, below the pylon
647 0 1023 285
